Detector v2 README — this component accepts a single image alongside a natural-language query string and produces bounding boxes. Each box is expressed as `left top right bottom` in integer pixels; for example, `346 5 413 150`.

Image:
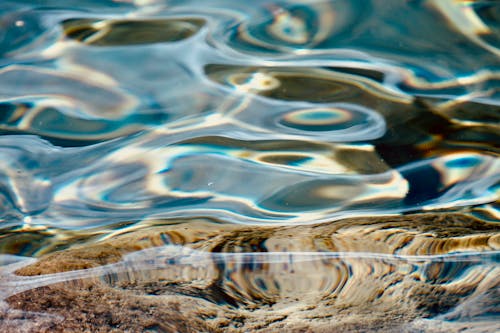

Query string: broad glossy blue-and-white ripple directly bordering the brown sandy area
0 128 498 228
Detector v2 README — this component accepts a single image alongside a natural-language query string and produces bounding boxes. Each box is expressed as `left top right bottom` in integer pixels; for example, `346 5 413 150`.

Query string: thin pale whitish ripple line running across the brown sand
0 245 500 300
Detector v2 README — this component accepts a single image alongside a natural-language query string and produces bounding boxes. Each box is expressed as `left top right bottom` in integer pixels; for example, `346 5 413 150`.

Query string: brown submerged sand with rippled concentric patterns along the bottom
0 214 500 332
